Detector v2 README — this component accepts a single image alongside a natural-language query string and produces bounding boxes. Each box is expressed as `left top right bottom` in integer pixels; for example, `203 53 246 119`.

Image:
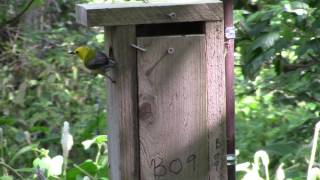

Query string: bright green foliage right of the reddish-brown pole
234 0 320 179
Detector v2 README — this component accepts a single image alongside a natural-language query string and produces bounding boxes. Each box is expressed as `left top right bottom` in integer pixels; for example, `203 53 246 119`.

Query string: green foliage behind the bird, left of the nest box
0 0 107 179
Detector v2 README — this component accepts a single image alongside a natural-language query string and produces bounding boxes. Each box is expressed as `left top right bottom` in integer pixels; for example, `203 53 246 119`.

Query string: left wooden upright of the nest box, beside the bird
106 26 140 180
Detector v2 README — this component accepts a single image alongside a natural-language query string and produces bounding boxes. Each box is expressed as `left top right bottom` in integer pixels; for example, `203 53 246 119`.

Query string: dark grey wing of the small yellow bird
86 52 115 69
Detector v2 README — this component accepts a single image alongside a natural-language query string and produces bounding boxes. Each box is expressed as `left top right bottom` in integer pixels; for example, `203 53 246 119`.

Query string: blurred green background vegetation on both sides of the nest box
0 0 320 179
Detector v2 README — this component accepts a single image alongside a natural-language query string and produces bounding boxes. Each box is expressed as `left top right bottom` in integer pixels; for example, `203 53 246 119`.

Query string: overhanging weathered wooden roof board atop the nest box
76 0 223 26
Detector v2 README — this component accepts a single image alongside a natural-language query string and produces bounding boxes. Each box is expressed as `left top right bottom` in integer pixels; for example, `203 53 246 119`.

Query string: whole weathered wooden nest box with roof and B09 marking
76 0 227 180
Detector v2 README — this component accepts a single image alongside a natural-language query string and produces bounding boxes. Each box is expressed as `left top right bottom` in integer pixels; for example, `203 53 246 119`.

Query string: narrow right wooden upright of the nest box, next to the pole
205 21 227 180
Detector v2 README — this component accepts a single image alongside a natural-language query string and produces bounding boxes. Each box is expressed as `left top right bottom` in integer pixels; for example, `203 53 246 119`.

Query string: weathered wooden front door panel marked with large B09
138 35 209 180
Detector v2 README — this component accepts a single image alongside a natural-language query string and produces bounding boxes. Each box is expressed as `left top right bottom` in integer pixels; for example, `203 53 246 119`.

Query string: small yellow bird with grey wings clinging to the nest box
69 46 116 82
